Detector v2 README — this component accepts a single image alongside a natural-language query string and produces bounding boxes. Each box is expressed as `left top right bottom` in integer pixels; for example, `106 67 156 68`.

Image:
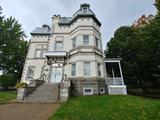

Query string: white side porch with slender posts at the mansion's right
105 58 127 95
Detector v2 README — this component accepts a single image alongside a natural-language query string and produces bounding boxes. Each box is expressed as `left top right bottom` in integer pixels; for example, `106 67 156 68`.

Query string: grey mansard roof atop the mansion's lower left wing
31 25 51 35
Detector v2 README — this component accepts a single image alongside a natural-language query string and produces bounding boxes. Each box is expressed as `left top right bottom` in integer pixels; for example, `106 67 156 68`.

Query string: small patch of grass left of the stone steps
0 91 16 104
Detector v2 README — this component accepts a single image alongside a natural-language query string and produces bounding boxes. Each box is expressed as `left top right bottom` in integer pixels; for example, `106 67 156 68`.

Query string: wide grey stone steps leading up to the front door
24 83 58 103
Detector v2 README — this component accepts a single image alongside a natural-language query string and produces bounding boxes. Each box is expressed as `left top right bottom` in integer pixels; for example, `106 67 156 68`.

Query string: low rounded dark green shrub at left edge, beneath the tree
0 74 16 89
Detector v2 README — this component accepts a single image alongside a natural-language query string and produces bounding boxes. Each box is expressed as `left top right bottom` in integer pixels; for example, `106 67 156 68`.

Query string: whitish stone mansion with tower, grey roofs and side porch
21 3 126 99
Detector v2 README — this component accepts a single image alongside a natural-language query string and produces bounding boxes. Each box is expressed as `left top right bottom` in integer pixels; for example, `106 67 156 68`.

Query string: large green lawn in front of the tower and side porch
49 95 160 120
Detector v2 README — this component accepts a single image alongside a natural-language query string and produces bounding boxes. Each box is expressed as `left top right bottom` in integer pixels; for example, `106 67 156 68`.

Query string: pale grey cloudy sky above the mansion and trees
0 0 156 49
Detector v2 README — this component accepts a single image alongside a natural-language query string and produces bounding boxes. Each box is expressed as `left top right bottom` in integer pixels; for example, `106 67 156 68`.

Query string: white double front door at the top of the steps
50 67 63 83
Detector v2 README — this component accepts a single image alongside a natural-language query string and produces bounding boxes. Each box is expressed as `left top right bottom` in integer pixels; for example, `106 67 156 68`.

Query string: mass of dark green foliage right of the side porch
106 2 160 90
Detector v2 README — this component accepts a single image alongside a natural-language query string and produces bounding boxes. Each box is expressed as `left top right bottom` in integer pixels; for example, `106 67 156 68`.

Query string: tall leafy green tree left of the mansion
0 7 28 88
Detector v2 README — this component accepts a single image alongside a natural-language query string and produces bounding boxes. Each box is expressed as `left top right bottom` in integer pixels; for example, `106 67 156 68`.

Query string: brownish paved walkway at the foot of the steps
0 103 60 120
